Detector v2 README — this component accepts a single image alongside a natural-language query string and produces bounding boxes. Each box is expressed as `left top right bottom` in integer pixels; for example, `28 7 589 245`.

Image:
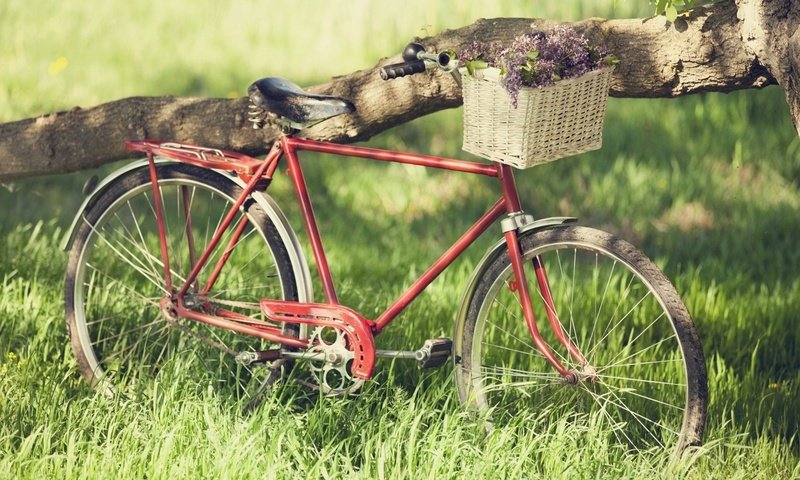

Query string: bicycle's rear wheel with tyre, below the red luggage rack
65 164 298 396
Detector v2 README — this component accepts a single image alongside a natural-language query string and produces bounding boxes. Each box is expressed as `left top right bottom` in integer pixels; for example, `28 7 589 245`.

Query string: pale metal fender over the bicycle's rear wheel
61 157 314 302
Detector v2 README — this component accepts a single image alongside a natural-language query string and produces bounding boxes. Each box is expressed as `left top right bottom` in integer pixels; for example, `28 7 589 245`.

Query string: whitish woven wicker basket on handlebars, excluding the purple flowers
462 67 613 168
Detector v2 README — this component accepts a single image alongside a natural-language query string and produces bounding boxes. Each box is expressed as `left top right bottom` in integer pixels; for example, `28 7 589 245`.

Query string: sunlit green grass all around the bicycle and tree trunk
0 0 800 479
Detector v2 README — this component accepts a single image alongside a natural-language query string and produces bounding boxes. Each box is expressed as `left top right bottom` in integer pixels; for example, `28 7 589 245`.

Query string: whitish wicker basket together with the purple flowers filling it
458 26 616 168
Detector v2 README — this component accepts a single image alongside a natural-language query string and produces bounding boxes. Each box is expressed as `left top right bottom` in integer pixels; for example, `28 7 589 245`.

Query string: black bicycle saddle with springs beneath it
247 77 356 130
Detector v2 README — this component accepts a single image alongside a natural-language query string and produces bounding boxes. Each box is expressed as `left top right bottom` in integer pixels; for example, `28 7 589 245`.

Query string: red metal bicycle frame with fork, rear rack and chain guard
126 135 585 381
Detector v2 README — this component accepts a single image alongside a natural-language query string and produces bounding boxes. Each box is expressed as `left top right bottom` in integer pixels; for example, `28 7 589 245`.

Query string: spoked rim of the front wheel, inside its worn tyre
467 241 689 451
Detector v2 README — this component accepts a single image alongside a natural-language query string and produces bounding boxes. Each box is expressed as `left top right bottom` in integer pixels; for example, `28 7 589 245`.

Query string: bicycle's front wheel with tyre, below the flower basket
456 227 707 452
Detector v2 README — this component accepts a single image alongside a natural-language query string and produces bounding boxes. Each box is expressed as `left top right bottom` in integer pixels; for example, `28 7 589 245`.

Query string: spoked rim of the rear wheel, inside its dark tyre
73 178 284 395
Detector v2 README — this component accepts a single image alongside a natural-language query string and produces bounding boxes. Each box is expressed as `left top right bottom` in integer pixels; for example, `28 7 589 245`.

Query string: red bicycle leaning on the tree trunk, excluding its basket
66 43 707 451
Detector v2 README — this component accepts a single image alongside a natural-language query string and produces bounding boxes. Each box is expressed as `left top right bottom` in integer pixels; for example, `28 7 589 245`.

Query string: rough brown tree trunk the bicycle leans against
0 0 800 181
